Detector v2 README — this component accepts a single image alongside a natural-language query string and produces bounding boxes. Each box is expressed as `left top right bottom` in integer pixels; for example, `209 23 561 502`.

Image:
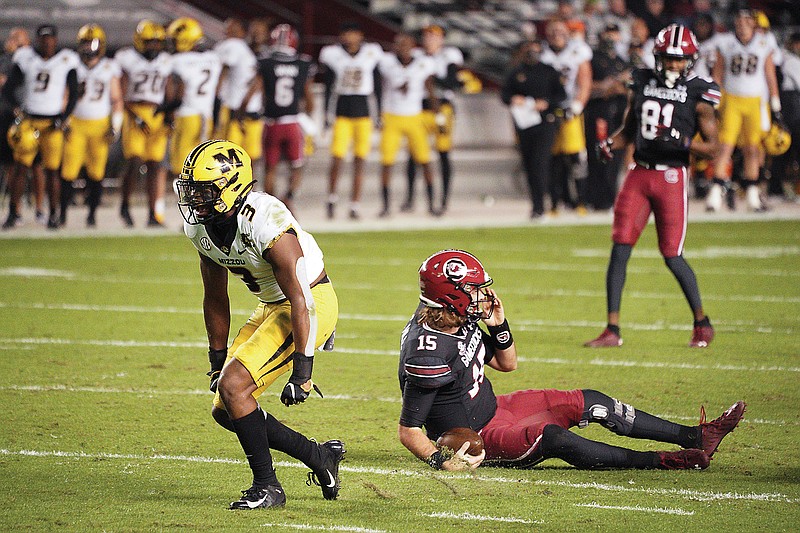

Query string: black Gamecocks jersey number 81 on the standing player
628 69 720 167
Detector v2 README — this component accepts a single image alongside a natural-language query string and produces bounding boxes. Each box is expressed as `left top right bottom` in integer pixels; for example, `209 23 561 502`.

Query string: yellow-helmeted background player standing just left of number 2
114 20 172 227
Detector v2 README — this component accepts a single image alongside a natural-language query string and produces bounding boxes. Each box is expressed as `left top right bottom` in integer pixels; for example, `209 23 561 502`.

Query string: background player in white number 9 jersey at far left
2 25 80 229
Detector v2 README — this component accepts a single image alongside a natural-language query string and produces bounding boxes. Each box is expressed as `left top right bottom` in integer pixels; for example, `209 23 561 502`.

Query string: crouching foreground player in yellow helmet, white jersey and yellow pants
175 140 345 510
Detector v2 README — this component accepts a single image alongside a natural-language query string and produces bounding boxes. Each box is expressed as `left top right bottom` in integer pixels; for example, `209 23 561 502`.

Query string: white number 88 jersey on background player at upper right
717 33 774 97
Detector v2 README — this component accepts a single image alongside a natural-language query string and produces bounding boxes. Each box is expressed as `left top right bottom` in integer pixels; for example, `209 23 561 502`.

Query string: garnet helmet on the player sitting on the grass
419 250 494 320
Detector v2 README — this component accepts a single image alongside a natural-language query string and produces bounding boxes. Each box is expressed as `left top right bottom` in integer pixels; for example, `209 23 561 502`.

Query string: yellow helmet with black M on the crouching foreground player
175 140 254 224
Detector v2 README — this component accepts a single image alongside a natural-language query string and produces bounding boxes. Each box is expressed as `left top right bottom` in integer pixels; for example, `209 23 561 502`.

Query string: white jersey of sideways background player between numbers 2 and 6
214 37 261 113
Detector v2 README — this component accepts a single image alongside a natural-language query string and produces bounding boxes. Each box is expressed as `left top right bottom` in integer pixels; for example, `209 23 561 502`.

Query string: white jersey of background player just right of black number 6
319 43 383 95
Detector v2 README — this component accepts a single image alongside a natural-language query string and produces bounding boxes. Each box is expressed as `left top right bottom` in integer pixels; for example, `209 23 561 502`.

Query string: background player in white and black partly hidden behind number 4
402 24 464 213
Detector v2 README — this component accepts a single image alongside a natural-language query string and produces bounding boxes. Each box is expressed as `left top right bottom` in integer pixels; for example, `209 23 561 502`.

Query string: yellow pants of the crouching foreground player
214 283 339 409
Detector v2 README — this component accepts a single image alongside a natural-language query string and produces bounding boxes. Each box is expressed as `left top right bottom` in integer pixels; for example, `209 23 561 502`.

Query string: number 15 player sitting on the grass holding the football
398 250 745 470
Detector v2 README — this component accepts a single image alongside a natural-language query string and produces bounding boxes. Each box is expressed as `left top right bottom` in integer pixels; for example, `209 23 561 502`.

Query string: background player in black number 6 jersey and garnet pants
237 24 316 208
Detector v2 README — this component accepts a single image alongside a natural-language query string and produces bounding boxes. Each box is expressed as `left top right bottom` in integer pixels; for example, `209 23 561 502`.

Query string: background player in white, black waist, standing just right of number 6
319 22 383 219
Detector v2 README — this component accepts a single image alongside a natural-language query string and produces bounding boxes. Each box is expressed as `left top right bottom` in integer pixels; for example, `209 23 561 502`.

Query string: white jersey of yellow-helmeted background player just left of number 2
114 47 172 104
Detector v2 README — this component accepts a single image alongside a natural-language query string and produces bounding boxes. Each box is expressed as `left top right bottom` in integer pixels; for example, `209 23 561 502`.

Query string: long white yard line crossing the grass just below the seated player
0 448 800 504
